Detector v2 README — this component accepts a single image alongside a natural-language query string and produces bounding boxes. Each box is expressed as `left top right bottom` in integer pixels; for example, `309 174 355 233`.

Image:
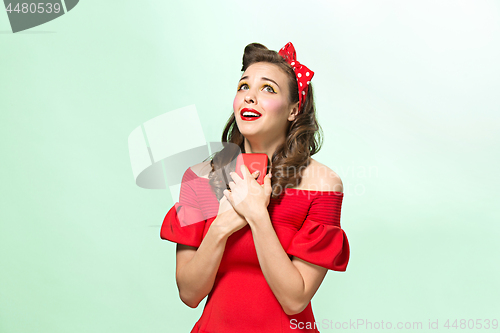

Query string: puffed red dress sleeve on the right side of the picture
286 191 349 272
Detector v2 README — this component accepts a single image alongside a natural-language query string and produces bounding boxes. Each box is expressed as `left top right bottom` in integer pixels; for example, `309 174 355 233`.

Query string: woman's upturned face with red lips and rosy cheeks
233 62 298 140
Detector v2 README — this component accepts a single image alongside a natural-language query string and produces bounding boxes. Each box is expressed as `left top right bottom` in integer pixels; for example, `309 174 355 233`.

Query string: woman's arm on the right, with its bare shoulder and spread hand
224 165 342 315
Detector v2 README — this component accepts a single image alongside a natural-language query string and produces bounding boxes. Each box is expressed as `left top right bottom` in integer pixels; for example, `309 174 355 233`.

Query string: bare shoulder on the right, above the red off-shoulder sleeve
300 158 344 192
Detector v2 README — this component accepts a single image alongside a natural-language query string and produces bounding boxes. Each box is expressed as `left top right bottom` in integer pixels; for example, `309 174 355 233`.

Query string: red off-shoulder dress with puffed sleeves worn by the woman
160 168 349 333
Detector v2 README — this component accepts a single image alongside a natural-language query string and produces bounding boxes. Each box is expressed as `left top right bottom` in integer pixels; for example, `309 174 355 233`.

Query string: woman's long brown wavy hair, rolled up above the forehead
204 43 323 200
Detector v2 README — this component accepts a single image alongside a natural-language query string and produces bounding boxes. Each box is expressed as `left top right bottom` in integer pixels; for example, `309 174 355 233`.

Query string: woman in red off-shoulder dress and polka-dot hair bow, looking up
160 43 349 333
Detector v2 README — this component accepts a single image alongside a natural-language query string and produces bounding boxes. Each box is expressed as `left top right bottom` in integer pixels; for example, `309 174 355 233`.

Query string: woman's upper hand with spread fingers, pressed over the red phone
224 165 272 224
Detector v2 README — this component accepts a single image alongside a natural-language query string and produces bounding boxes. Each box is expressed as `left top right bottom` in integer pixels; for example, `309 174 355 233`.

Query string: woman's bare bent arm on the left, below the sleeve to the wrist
175 217 229 308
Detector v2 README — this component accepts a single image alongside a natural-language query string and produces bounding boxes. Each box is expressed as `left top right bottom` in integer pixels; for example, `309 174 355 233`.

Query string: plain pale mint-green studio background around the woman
0 0 500 333
